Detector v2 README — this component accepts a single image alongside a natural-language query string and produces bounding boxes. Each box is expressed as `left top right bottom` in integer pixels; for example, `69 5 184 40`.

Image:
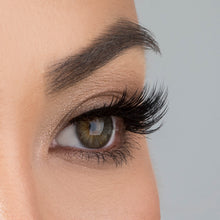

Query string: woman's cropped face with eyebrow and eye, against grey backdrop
0 0 160 220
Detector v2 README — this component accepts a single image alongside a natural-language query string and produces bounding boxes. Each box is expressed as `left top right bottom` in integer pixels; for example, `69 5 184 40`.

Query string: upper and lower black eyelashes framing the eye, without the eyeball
49 85 168 166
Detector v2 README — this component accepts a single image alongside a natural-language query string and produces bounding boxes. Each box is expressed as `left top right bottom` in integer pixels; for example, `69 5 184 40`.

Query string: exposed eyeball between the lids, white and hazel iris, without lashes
53 116 122 150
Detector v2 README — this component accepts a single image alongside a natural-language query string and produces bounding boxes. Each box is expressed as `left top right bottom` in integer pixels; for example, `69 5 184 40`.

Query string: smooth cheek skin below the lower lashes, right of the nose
35 138 160 220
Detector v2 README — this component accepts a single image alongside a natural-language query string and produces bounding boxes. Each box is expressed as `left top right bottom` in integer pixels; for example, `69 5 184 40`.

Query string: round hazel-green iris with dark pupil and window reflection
76 117 113 149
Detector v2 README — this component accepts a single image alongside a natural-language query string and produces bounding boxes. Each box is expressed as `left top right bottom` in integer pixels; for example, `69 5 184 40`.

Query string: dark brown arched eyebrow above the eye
46 19 160 95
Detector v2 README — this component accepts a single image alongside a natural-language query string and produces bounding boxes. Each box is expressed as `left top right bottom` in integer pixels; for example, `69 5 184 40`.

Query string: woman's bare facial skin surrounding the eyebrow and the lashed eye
0 0 160 220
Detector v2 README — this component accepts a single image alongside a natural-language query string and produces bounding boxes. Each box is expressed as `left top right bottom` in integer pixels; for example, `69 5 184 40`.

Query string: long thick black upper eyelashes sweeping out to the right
70 84 168 135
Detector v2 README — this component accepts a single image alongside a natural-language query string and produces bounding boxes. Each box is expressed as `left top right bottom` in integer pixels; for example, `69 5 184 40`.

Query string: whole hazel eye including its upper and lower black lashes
49 85 168 166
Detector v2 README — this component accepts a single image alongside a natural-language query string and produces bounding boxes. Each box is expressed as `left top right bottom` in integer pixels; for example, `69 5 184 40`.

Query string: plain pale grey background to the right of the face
135 0 220 220
